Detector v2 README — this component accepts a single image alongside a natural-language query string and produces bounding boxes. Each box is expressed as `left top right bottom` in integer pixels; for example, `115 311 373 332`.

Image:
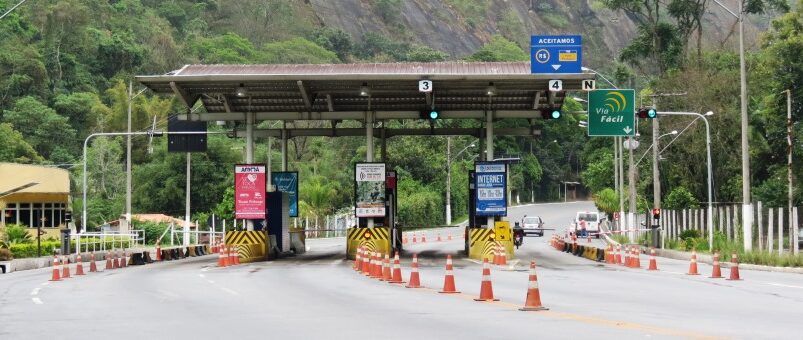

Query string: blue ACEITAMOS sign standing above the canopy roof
530 35 583 74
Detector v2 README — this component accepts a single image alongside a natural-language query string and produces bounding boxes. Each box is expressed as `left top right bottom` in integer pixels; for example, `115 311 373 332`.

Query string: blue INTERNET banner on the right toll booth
474 162 507 216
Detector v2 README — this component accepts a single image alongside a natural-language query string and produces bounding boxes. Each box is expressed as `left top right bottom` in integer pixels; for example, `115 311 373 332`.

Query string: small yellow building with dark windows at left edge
0 163 71 229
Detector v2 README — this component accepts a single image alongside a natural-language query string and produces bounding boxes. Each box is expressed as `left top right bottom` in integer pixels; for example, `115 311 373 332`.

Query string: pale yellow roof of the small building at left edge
0 163 70 197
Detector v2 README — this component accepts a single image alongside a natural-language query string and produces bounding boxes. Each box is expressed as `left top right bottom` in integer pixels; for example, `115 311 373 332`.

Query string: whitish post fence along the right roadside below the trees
661 202 800 254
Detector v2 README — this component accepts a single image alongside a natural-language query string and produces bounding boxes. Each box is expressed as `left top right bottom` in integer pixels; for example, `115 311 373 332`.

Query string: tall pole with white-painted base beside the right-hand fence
714 0 753 251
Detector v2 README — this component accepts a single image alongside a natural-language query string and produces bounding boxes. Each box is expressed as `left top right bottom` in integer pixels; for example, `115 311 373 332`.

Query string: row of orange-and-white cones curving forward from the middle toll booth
352 246 547 311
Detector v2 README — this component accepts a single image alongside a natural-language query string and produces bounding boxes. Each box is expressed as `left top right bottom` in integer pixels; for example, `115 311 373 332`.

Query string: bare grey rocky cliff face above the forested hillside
305 0 767 66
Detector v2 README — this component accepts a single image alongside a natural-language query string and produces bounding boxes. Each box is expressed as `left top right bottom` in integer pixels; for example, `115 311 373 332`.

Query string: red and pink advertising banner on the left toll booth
234 164 267 220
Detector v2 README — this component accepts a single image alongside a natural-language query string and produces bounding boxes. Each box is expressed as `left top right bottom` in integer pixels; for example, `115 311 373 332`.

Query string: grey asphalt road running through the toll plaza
0 203 803 339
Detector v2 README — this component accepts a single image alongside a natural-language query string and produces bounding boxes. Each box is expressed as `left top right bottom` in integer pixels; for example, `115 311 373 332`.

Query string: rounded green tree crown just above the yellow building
2 97 77 158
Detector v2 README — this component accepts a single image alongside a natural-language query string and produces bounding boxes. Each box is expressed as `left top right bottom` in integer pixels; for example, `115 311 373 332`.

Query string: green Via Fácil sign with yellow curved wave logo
588 90 636 136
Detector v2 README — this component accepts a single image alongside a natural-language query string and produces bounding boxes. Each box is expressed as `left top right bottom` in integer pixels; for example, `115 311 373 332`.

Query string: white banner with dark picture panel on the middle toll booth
354 163 385 217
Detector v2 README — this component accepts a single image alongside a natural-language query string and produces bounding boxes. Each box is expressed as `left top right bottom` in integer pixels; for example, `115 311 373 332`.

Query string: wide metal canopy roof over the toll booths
136 62 596 120
